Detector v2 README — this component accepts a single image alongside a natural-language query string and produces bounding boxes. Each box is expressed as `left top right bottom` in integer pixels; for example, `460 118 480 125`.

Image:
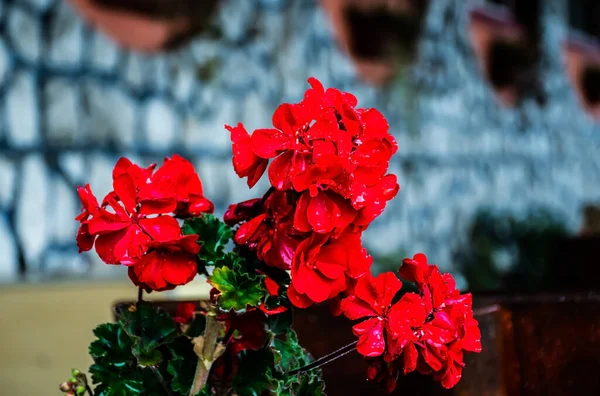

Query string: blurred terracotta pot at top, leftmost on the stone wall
69 0 218 52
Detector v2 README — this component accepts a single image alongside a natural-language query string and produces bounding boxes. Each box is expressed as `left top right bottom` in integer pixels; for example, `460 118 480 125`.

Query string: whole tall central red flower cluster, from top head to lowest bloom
225 78 399 307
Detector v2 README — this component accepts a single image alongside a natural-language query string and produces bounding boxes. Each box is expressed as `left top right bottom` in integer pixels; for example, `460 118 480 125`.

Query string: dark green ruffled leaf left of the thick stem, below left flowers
115 301 177 366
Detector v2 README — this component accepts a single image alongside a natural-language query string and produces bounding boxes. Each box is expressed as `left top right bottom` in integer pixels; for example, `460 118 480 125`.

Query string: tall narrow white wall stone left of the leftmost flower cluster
16 154 48 273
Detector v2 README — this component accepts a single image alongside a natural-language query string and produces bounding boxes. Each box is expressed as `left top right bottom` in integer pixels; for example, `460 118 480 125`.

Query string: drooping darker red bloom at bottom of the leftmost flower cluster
129 235 200 291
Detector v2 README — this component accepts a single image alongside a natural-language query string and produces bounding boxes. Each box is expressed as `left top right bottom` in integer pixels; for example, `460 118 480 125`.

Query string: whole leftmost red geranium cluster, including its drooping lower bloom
76 155 213 290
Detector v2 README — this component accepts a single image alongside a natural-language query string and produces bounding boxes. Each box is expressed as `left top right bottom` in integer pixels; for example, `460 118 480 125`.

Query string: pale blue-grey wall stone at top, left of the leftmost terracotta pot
48 1 84 66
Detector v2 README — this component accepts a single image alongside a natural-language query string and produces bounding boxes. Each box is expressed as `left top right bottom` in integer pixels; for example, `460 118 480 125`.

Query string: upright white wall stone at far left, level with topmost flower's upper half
6 72 40 147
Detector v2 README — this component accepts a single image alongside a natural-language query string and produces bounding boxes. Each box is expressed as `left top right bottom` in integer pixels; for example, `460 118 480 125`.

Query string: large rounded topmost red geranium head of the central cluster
227 78 399 233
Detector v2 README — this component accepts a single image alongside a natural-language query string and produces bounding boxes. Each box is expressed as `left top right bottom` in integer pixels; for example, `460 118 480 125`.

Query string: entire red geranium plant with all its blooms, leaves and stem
60 78 481 396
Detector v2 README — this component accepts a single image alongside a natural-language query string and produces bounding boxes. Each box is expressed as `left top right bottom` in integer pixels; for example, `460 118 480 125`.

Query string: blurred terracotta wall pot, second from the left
321 0 428 85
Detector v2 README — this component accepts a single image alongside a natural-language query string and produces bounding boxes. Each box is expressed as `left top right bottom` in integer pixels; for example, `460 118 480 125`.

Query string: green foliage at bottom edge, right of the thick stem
233 330 325 396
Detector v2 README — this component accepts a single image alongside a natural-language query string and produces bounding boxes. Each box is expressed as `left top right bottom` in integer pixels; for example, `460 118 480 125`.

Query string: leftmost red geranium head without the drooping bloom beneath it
76 156 212 265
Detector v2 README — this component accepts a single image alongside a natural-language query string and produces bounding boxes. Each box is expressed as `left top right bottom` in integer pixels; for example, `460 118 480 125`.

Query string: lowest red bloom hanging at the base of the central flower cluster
288 233 373 307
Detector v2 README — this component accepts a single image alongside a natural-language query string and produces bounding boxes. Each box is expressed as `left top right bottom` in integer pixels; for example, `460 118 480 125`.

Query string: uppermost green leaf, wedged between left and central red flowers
182 214 233 275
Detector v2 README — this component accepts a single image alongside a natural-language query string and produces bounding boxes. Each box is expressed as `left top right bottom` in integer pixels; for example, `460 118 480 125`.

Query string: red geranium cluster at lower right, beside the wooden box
341 254 481 390
